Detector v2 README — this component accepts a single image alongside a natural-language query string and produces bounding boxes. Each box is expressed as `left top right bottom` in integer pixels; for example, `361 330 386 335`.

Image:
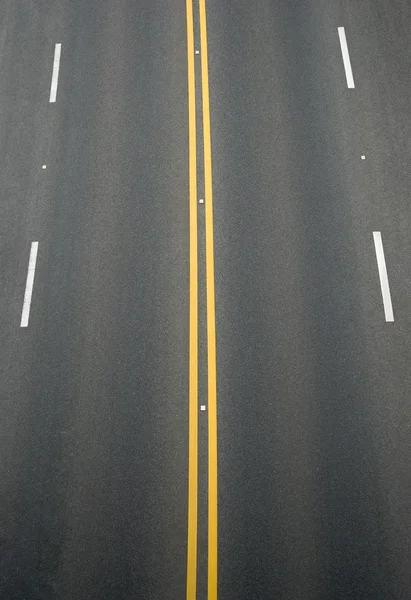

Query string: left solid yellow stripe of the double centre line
186 0 198 600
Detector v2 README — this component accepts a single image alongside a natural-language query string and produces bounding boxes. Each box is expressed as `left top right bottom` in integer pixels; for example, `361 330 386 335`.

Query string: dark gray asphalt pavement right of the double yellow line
208 0 411 600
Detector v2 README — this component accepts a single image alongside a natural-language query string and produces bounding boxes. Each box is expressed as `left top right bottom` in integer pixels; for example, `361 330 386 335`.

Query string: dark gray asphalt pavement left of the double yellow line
0 0 188 600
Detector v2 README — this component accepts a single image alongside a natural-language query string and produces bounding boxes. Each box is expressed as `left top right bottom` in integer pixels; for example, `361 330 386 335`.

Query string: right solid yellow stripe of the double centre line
200 0 217 600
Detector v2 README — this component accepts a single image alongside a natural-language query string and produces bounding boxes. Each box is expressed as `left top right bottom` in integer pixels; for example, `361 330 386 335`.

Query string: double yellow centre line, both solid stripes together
186 0 218 600
